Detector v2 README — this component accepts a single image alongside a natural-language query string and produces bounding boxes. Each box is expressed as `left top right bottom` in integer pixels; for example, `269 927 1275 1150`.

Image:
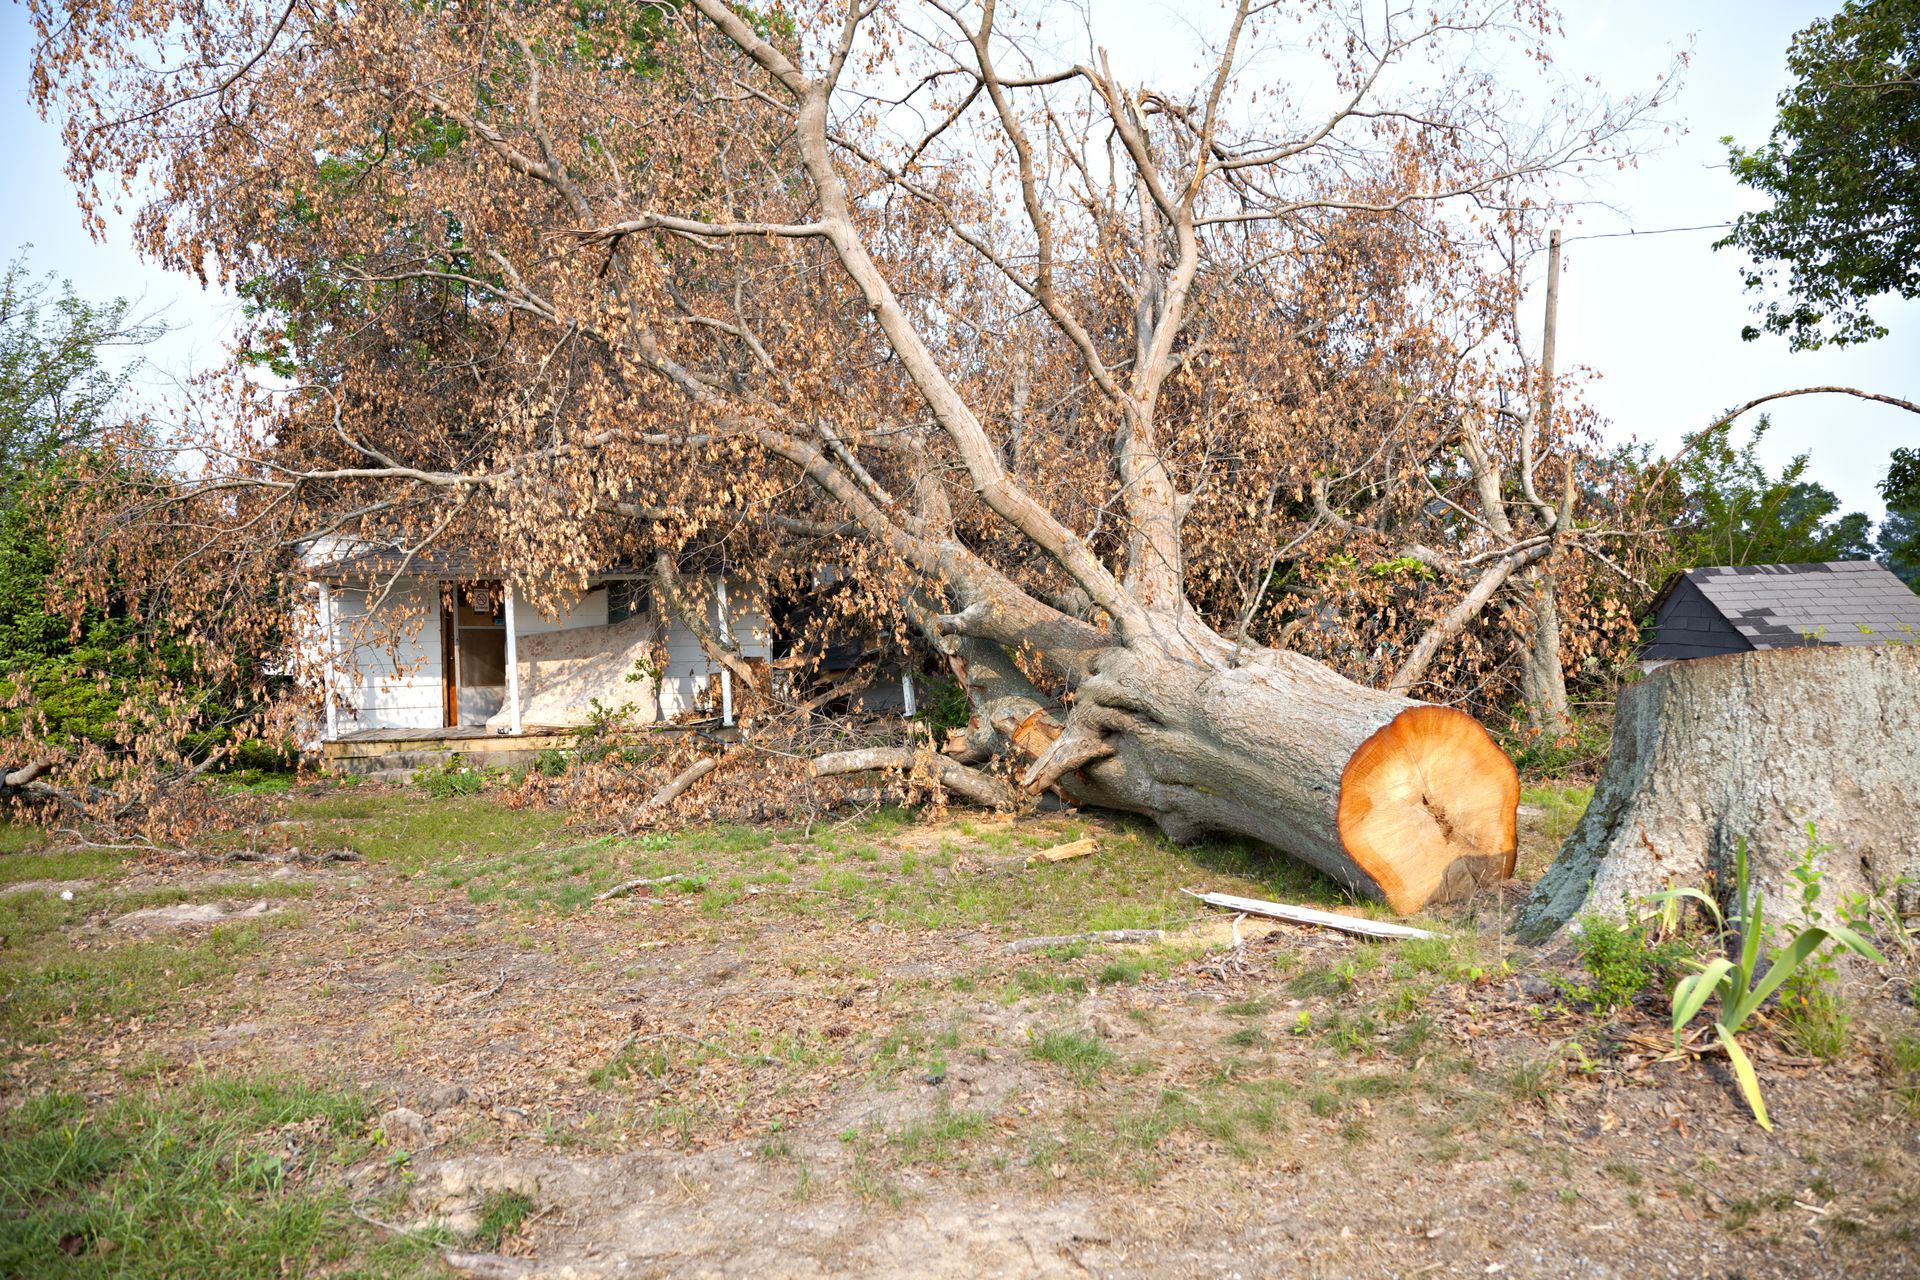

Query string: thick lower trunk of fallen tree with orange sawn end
921 624 1519 912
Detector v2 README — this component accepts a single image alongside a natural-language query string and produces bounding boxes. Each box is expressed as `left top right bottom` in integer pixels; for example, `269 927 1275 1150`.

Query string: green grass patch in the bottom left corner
0 1077 436 1280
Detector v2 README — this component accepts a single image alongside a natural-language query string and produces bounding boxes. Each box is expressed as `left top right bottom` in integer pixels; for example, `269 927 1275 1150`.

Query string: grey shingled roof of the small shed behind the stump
1653 560 1920 649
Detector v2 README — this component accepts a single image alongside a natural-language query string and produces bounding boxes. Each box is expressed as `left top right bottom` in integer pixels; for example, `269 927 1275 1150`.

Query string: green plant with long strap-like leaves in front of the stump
1653 827 1885 1130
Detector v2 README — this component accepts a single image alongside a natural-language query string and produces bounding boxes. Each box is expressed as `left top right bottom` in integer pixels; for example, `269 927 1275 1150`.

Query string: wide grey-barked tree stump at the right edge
1521 645 1920 938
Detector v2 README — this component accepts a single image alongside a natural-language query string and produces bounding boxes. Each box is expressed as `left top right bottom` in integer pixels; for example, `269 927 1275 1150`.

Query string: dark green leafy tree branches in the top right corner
1716 0 1920 349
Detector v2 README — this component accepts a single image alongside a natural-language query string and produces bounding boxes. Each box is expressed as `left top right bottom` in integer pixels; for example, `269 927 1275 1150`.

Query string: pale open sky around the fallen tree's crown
0 0 1920 518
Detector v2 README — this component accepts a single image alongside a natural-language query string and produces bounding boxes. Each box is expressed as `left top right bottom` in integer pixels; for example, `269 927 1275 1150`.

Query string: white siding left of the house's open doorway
334 580 445 733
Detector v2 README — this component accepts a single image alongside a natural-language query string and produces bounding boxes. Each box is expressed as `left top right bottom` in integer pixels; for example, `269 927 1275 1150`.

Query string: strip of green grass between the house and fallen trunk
259 791 1380 936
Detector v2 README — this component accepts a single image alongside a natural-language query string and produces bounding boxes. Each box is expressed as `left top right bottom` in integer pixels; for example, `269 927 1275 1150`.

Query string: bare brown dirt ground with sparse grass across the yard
0 789 1920 1278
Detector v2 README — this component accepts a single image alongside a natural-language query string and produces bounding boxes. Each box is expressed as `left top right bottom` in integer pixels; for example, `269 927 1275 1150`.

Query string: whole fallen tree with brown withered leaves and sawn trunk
35 0 1681 912
